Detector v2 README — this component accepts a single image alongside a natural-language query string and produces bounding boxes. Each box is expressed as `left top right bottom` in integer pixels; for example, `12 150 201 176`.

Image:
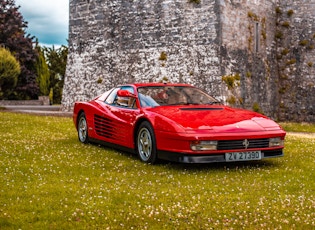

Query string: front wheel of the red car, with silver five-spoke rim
136 121 157 164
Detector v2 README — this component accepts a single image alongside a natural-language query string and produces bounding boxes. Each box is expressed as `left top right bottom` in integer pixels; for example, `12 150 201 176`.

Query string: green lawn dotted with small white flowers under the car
0 112 315 230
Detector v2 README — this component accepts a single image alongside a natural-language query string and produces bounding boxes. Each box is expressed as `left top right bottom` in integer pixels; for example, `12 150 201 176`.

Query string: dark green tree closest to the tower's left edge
44 46 68 104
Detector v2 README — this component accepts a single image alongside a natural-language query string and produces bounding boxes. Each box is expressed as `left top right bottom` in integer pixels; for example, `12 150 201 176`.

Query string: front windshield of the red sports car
138 86 219 107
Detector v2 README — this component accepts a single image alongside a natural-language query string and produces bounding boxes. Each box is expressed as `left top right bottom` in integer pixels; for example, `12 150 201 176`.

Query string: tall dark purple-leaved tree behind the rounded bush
0 0 39 99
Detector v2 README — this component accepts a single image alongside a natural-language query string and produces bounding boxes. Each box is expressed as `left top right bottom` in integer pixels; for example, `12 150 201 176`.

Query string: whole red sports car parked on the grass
73 83 286 163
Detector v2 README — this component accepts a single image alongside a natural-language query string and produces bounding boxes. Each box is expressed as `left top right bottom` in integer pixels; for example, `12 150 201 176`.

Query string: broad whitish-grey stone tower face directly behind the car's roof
62 0 222 108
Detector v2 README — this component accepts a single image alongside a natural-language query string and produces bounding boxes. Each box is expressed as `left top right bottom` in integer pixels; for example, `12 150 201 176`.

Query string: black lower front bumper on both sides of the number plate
158 149 284 163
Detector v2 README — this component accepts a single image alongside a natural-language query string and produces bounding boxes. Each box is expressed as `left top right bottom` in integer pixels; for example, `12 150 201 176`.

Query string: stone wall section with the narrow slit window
221 0 278 119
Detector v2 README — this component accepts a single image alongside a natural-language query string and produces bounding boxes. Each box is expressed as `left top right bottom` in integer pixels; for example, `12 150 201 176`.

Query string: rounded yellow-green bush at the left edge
0 47 21 99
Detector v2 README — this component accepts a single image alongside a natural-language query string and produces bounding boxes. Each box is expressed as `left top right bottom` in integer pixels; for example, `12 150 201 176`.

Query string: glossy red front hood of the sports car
150 106 280 132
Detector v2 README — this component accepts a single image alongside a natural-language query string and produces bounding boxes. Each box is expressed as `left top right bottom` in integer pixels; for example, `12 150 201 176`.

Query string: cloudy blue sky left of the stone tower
15 0 69 47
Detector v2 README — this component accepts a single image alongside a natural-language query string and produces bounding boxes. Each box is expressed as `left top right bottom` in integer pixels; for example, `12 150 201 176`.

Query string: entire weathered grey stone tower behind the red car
62 0 315 121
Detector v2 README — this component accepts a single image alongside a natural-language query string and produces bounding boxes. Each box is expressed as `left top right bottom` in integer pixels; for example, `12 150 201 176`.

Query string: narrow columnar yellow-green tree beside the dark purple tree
35 44 50 96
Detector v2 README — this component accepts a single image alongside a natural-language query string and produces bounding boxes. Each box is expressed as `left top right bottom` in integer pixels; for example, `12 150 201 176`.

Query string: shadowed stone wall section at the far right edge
277 0 315 122
